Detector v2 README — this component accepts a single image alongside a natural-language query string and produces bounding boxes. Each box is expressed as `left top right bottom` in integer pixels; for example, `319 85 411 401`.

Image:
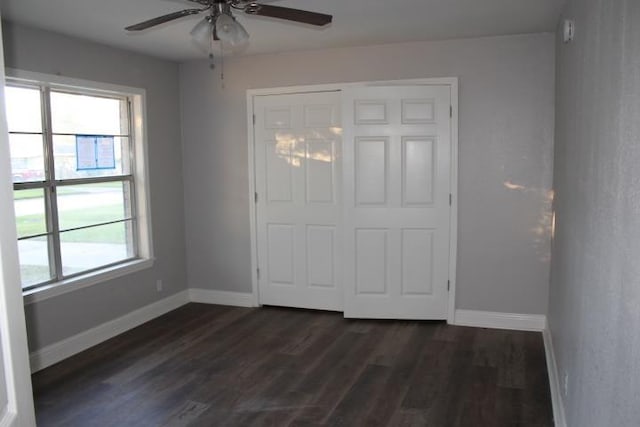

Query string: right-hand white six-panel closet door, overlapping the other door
343 86 451 319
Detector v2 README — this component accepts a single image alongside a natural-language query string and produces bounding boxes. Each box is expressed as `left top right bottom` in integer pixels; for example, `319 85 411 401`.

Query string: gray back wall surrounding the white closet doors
180 34 555 314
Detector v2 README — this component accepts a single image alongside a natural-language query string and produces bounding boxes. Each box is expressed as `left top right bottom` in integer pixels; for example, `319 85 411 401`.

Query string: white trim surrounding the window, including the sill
6 68 154 304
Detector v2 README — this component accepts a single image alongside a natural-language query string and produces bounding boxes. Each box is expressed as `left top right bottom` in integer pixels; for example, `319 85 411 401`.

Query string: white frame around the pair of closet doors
246 77 458 324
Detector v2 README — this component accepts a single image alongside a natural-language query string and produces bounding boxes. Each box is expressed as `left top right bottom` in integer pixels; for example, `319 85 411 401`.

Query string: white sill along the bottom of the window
22 258 153 305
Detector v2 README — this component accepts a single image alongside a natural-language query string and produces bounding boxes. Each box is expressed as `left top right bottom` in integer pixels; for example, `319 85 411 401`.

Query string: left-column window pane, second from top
9 134 44 182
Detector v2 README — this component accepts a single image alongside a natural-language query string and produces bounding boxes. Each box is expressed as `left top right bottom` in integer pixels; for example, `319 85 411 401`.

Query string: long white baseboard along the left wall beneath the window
29 291 189 372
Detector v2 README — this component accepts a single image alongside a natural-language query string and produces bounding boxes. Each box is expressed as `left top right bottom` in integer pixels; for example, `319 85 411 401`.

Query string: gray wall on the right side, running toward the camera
549 0 640 427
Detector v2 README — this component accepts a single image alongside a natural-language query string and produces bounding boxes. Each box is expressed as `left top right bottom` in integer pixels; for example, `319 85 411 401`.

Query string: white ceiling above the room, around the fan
2 0 564 61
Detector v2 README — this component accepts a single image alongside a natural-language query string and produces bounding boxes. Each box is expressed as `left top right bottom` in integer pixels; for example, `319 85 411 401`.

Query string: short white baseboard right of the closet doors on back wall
454 310 547 332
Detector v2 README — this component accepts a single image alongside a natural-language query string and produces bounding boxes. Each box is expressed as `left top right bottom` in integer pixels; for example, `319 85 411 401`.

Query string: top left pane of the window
5 86 42 132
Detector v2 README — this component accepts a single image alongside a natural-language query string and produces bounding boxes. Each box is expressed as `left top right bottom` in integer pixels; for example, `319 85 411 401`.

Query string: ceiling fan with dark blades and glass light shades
125 0 333 46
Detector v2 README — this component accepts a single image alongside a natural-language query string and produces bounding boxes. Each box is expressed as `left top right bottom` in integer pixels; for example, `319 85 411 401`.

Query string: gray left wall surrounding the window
3 23 186 351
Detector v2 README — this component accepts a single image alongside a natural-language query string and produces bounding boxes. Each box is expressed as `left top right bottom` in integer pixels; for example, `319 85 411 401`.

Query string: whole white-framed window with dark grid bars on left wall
5 72 150 298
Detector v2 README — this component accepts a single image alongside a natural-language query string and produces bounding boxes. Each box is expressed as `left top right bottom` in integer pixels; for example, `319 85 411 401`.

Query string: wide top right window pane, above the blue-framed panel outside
51 91 129 135
